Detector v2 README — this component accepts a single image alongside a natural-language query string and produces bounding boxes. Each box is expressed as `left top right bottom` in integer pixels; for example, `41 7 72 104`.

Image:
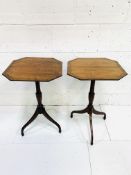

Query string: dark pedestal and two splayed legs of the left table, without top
21 81 61 136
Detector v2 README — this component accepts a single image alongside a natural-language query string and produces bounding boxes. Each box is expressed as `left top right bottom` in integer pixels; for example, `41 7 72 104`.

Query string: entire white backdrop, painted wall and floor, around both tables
0 0 131 175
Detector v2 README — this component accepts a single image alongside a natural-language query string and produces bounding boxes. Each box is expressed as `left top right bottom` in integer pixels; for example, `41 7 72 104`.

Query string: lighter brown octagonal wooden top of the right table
67 58 127 80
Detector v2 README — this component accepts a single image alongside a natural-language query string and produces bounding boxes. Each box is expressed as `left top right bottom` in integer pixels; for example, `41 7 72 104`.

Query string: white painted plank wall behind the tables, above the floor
0 0 131 105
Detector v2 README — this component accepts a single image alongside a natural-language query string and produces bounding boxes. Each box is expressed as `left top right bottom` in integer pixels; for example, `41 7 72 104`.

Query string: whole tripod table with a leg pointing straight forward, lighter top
67 58 127 145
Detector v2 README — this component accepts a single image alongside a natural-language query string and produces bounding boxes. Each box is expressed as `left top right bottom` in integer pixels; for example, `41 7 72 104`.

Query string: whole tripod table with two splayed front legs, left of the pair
3 57 62 136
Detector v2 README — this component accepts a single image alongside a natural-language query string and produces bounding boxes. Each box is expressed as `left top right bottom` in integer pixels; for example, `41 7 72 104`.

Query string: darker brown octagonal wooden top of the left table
3 57 62 81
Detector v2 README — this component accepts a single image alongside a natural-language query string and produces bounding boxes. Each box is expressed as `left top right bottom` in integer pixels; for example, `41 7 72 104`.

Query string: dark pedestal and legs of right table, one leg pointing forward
71 80 106 145
